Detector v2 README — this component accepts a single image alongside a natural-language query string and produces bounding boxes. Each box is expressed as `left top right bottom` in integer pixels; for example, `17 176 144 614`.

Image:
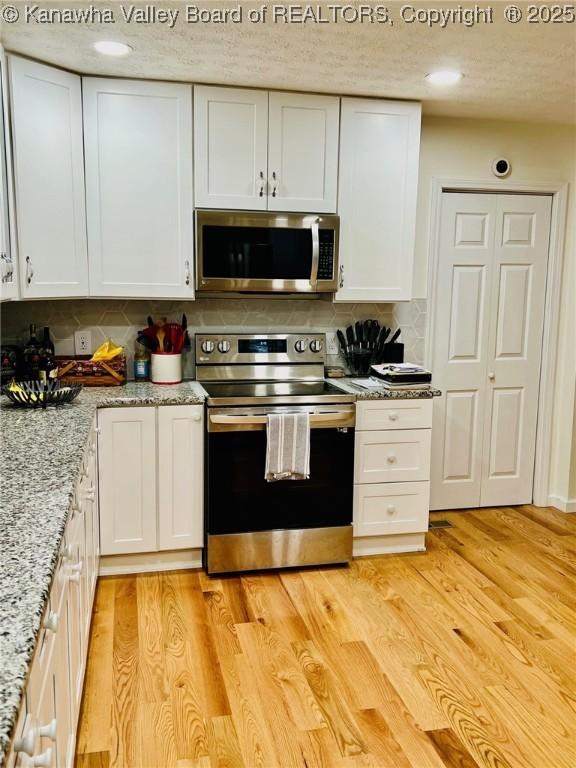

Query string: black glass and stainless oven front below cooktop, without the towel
205 405 355 573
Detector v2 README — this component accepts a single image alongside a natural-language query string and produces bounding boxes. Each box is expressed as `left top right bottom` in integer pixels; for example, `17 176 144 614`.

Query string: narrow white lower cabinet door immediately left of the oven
158 405 204 549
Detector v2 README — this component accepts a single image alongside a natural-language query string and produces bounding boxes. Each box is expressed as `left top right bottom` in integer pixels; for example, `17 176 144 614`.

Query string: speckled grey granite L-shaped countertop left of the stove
0 381 205 765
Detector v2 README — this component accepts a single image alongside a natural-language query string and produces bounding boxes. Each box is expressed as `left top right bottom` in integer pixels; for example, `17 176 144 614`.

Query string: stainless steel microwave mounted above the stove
196 210 340 293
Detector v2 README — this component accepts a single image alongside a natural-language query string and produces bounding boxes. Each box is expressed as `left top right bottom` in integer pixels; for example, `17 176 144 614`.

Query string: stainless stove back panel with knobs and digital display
196 332 326 365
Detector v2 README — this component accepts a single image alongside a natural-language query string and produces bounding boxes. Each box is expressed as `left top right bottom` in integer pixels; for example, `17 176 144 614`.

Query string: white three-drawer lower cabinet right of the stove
354 399 432 555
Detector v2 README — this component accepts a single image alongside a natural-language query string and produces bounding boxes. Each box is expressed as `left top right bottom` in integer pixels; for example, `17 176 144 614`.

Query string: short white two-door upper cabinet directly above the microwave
194 86 340 213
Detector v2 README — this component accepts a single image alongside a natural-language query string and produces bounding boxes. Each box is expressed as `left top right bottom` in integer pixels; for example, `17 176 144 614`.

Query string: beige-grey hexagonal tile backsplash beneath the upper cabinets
0 298 427 377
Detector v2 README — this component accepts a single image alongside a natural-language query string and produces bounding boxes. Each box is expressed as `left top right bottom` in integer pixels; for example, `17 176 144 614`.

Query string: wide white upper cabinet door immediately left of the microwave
83 77 194 299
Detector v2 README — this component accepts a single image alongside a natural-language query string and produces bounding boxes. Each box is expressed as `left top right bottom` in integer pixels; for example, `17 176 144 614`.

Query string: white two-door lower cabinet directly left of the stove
98 405 204 555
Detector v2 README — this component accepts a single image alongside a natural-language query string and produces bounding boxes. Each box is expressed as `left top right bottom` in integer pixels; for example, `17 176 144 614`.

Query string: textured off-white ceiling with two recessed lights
0 0 576 123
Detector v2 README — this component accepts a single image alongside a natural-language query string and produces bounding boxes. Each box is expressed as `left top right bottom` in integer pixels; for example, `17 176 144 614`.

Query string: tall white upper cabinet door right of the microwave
335 99 421 301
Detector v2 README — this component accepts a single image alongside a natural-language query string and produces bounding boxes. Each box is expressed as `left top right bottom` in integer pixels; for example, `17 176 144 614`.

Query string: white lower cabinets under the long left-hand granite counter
6 425 98 768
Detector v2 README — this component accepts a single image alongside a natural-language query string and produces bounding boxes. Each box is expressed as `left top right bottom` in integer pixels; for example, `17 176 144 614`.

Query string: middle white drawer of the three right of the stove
354 429 432 483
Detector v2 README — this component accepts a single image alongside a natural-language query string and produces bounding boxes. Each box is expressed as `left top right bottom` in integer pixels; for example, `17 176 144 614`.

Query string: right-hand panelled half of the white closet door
480 195 552 506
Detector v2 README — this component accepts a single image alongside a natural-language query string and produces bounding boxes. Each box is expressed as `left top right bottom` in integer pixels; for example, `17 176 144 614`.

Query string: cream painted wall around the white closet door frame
414 117 576 510
